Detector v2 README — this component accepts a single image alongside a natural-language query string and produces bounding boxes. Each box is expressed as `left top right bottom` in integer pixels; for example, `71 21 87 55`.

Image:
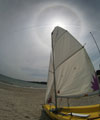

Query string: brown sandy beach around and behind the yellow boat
0 83 100 120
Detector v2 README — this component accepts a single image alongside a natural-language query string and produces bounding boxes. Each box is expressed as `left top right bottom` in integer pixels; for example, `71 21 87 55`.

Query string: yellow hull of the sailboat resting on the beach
43 104 100 120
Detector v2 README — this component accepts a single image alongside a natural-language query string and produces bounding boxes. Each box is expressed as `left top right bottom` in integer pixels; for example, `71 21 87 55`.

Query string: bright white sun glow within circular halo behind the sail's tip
36 5 81 46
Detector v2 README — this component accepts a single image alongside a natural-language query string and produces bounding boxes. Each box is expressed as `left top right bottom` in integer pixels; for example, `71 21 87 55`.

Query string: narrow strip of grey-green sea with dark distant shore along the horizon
0 74 47 87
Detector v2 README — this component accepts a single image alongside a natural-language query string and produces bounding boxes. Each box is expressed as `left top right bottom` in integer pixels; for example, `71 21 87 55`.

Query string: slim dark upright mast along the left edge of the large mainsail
52 32 57 111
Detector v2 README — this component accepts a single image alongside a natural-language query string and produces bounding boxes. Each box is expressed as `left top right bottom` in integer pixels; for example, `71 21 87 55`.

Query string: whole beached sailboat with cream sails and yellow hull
43 26 100 120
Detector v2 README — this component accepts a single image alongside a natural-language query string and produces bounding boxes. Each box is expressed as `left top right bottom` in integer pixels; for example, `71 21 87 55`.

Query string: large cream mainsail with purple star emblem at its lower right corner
46 27 99 103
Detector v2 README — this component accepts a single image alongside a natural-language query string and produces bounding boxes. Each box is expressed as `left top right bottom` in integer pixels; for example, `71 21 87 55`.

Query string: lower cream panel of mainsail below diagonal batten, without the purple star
56 48 95 96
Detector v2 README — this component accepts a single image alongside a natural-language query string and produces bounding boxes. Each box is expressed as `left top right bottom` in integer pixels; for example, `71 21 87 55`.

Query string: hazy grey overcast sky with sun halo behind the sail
0 0 100 81
